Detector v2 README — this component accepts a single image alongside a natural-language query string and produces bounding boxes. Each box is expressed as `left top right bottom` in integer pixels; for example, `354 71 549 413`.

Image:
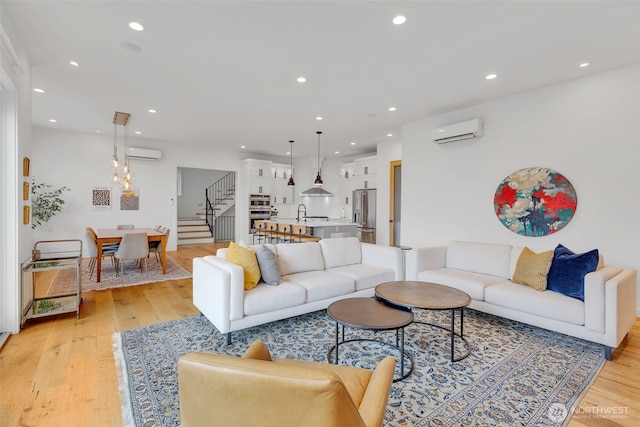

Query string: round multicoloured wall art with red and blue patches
493 167 578 237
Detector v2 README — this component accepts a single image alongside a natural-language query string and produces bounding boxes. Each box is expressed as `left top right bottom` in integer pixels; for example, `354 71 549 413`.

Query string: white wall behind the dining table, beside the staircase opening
31 129 244 255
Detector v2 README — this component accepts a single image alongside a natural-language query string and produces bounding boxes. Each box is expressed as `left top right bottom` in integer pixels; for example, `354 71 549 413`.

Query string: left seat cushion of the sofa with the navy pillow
417 268 505 301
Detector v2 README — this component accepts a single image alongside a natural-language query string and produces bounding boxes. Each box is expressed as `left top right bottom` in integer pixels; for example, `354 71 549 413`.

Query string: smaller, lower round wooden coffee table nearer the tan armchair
327 298 414 382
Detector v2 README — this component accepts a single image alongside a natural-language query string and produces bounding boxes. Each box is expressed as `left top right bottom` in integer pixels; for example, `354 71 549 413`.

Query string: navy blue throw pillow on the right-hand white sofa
547 245 599 301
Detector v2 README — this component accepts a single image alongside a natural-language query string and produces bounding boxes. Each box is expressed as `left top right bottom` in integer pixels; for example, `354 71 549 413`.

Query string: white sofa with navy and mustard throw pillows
406 241 636 360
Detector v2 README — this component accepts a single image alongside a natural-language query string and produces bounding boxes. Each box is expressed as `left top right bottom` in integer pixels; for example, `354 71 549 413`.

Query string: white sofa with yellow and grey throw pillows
193 237 404 343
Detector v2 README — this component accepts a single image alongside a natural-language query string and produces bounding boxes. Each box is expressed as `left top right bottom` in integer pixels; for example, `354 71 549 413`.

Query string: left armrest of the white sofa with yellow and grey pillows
193 256 244 334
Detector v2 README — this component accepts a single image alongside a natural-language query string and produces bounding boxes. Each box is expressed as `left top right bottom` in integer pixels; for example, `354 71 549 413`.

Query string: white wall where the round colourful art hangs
402 64 640 314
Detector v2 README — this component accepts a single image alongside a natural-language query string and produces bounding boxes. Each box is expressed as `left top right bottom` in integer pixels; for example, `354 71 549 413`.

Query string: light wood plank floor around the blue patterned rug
0 244 640 427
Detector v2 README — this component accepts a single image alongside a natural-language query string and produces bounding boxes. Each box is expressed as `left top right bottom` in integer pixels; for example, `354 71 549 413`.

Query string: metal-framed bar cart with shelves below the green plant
20 239 82 326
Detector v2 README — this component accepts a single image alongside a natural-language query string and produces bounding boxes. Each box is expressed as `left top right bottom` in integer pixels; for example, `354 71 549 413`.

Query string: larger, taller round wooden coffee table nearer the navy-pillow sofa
375 280 471 362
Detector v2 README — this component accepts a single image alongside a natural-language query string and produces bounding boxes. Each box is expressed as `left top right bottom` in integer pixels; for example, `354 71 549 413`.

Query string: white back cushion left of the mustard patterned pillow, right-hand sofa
446 241 512 280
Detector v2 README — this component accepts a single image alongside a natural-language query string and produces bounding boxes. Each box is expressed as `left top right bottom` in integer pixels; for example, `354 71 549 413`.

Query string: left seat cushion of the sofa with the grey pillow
244 280 307 316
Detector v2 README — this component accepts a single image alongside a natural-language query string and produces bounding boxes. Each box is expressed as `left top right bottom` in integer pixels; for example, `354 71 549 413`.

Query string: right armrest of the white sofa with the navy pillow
604 268 636 347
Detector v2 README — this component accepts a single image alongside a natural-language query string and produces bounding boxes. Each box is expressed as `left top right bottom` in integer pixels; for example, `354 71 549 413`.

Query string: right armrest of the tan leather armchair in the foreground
358 356 396 427
